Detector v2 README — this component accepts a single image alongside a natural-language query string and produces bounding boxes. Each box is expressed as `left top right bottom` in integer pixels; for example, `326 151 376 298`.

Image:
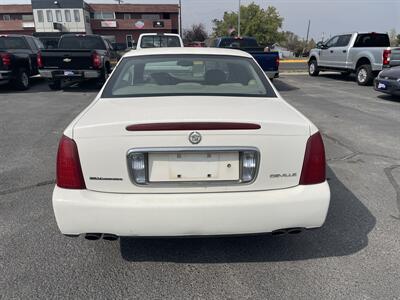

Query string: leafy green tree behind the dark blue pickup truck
213 3 283 45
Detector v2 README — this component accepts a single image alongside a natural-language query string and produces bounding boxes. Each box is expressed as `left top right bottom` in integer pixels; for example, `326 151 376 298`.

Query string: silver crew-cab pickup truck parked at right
308 32 391 85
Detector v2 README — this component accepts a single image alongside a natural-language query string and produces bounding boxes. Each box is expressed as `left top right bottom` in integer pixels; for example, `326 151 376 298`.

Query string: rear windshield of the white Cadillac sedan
102 55 276 98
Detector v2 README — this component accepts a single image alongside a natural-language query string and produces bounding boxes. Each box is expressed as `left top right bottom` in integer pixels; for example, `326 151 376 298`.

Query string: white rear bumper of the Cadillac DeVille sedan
53 182 330 236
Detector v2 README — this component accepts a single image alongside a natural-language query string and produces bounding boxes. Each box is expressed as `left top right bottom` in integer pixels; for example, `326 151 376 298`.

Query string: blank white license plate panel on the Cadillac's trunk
148 152 239 182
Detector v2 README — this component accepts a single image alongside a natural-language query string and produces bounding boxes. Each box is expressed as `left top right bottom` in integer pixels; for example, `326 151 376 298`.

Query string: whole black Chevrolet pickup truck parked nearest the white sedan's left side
38 34 119 90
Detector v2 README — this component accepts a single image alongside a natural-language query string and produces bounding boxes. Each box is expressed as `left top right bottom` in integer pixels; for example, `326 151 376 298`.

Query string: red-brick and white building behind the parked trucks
0 0 180 46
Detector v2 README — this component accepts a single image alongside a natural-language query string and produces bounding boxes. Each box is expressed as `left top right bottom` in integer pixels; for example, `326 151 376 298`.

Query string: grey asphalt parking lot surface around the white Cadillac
0 75 400 299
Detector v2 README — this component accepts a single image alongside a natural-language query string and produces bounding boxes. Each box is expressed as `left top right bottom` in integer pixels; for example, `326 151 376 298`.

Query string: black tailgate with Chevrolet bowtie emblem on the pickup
42 49 93 70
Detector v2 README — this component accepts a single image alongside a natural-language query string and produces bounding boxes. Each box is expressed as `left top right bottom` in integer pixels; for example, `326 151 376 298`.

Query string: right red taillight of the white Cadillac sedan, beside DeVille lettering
300 132 326 185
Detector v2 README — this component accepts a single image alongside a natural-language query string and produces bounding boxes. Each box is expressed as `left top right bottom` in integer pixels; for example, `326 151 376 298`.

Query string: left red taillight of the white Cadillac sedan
57 135 86 190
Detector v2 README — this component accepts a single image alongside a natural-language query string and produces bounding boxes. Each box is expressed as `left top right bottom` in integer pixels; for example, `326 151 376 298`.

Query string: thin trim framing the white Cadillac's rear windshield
100 54 278 99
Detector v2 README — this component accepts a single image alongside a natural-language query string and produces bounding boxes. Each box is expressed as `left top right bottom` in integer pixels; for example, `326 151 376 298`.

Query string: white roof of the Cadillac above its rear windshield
124 47 252 58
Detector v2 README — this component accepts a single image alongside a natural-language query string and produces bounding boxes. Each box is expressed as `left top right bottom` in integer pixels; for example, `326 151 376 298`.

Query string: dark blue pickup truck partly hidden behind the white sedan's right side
206 37 279 80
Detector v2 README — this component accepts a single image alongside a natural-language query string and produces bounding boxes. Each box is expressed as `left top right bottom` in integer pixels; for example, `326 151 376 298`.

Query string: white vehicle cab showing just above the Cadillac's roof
136 33 183 50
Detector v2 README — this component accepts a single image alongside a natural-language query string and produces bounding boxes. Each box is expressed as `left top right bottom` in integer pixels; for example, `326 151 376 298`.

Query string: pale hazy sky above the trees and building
0 0 400 41
